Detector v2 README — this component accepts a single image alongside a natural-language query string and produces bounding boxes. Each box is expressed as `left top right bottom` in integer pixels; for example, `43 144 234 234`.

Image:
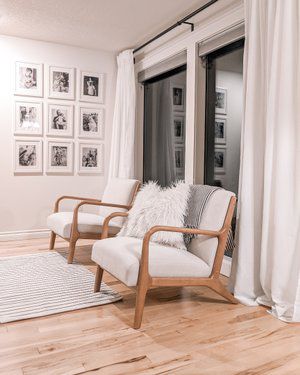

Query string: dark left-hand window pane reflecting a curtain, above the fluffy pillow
143 65 186 186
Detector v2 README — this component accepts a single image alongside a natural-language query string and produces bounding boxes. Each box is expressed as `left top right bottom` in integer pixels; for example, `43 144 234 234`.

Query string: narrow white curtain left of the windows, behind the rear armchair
108 50 136 178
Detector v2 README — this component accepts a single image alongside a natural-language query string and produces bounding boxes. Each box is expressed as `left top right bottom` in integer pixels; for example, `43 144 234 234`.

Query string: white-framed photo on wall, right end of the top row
80 72 104 104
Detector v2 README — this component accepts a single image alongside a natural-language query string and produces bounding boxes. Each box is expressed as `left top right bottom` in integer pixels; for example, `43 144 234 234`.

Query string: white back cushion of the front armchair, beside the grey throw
188 189 234 267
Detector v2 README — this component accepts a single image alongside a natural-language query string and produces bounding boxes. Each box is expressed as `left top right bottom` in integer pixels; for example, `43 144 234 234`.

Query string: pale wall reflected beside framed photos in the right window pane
216 70 243 194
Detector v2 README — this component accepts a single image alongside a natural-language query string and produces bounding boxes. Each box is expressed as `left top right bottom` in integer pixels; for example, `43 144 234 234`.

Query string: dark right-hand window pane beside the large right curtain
204 40 244 256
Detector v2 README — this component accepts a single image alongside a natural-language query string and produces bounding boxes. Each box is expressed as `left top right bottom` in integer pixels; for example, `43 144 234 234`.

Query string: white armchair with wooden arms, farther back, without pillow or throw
47 178 140 263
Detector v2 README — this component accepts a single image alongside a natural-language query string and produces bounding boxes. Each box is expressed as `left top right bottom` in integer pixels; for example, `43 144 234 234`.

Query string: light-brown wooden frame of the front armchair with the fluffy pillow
94 197 238 329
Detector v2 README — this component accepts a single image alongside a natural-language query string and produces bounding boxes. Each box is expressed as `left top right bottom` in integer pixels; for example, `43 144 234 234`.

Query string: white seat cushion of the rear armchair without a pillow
47 212 121 238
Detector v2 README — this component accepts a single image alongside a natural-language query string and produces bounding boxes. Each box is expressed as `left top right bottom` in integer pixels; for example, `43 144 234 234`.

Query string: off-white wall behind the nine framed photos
0 36 116 235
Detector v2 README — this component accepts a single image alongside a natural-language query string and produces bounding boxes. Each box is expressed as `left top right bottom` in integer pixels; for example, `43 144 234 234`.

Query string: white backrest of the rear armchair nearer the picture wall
99 178 140 227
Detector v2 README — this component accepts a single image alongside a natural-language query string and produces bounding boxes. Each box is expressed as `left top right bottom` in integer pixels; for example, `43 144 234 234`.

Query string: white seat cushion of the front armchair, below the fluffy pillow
92 237 211 286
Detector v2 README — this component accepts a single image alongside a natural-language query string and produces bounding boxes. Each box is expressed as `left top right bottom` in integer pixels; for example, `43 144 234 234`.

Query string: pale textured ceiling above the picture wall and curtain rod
0 0 206 51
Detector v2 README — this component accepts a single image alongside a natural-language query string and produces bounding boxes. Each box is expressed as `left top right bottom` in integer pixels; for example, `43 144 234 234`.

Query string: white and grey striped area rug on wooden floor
0 252 122 323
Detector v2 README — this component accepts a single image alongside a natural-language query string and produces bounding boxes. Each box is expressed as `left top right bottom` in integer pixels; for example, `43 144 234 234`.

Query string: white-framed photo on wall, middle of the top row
49 66 75 100
